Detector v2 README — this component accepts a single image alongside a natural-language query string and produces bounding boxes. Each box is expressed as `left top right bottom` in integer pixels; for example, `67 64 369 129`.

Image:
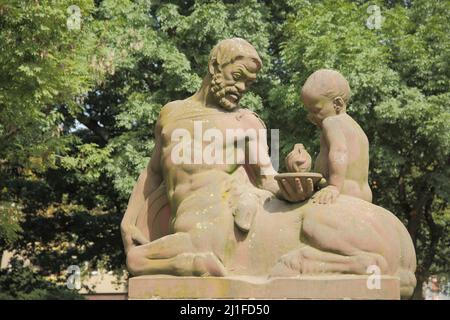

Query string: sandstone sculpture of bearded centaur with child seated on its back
121 38 416 298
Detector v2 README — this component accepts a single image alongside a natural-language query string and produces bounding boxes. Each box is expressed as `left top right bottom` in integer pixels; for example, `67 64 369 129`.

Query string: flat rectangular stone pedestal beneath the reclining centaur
128 275 400 299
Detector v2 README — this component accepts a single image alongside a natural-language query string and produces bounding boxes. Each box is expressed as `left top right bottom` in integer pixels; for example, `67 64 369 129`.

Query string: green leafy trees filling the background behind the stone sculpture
0 0 450 298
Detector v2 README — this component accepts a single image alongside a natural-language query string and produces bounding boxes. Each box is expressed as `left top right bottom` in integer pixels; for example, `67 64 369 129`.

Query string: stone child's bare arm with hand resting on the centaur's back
313 117 348 204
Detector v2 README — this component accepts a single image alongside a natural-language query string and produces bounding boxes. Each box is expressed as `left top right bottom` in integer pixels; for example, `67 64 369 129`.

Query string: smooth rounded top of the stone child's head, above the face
301 69 351 104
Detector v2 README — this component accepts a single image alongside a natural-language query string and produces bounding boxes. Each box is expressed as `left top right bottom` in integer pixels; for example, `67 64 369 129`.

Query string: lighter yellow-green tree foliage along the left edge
0 1 97 249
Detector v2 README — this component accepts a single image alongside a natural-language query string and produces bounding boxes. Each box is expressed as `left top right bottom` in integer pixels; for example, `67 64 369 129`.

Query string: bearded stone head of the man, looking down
208 38 262 110
